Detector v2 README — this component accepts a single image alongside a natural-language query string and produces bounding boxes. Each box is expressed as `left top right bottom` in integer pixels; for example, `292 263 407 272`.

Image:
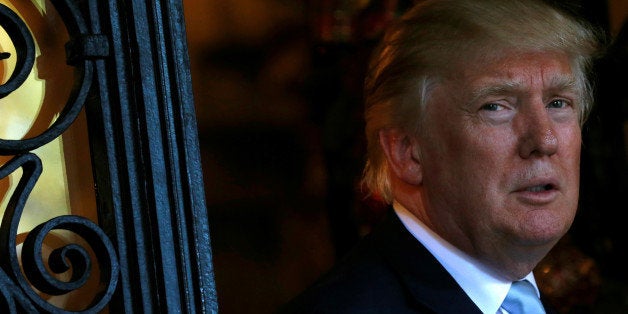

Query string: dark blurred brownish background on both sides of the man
183 0 628 314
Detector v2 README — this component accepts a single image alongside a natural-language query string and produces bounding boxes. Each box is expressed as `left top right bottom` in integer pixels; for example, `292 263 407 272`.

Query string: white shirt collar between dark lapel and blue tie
393 202 540 314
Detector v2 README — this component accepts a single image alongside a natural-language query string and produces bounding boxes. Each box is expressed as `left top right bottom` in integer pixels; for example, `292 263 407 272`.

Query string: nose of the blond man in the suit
519 106 558 159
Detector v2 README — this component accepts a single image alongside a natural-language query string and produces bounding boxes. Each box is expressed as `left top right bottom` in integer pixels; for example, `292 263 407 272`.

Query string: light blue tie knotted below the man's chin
502 280 545 314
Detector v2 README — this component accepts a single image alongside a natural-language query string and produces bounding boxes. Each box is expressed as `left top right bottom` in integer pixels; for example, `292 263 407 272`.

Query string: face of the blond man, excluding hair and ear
419 52 582 272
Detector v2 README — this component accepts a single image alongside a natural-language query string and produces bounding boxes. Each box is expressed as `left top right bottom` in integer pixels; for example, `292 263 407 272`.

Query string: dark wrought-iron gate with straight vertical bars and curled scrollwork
0 0 217 313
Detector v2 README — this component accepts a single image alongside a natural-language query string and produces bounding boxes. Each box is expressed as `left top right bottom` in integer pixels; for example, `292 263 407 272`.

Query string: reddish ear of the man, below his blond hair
379 129 423 185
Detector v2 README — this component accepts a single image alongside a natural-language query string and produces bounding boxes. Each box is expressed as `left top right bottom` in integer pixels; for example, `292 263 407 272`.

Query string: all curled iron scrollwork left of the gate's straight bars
0 0 119 313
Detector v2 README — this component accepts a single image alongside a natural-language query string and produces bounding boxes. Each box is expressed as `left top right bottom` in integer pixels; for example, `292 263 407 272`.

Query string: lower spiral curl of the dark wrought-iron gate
0 154 119 313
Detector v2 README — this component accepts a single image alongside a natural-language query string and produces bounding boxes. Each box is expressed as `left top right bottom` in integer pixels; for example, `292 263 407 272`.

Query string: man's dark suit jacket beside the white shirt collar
279 209 553 314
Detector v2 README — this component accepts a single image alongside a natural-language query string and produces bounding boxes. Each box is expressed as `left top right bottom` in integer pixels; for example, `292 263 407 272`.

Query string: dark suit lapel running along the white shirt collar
373 210 481 313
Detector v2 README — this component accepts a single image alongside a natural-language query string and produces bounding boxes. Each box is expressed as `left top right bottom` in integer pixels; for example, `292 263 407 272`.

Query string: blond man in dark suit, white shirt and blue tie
284 0 598 314
